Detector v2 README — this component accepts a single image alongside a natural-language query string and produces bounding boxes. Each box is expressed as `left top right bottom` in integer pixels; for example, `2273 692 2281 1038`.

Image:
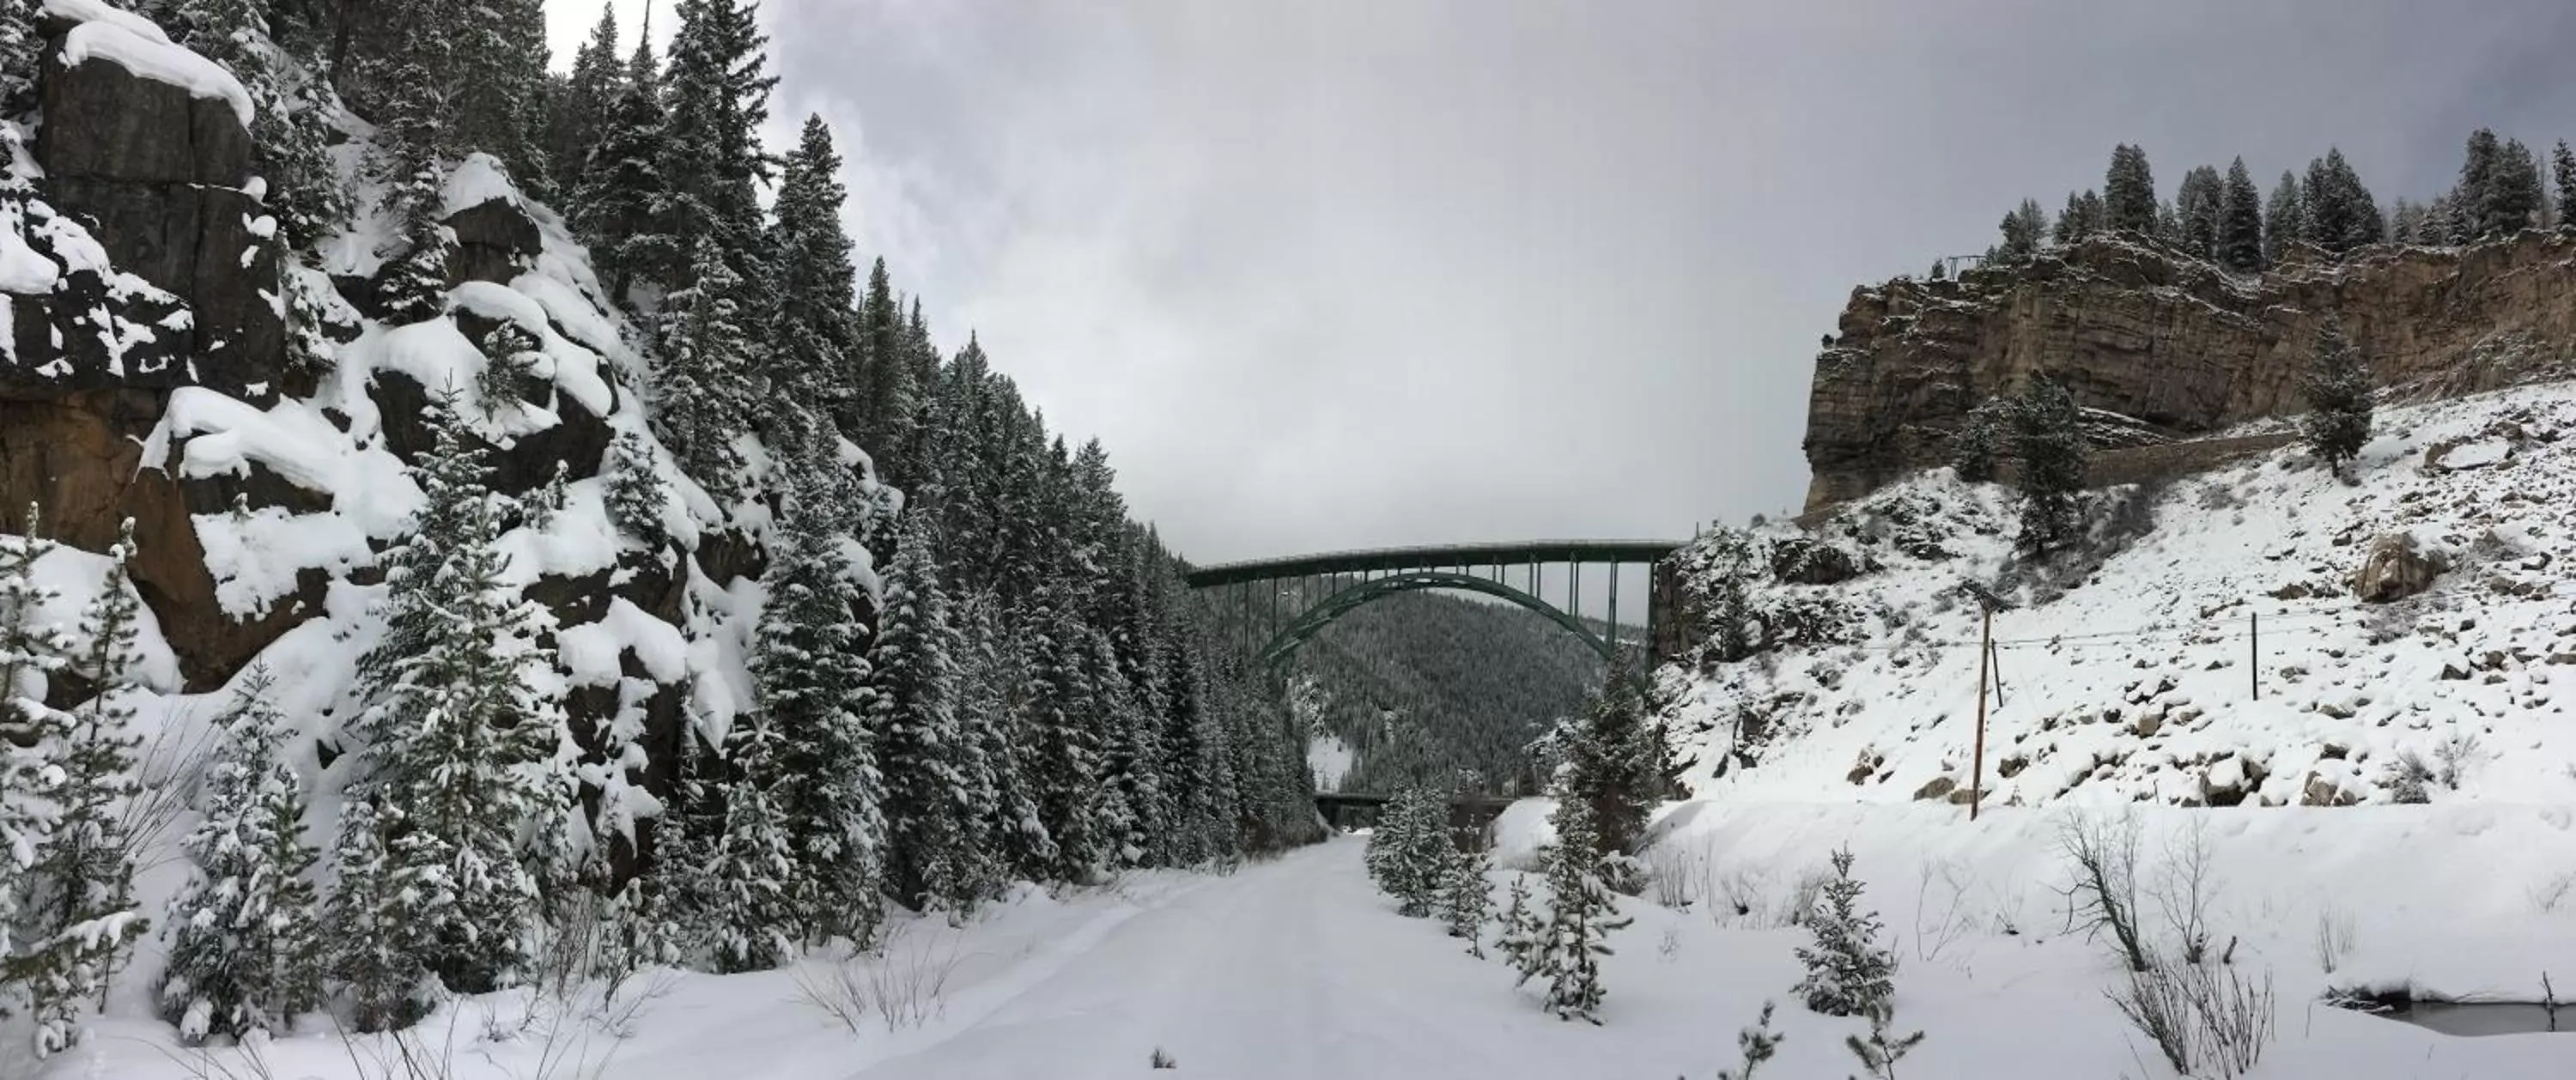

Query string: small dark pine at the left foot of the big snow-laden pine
322 799 433 1031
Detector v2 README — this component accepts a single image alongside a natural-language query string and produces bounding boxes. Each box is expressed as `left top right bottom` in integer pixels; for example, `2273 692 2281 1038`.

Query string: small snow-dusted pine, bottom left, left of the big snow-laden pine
160 668 322 1044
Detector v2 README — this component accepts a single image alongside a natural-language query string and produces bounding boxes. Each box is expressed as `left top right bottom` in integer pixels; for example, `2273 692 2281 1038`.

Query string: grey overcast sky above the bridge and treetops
549 0 2576 574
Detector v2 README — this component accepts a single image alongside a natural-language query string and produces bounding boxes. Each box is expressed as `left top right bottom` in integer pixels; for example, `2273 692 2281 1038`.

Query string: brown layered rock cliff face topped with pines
1803 232 2576 510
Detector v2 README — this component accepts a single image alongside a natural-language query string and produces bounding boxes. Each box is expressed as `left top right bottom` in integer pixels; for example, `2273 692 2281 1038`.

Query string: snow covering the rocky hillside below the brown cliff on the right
1662 384 2576 812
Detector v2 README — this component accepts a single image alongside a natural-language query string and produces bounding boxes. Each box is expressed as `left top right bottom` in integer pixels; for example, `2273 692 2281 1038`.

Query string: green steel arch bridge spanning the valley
1185 538 1685 681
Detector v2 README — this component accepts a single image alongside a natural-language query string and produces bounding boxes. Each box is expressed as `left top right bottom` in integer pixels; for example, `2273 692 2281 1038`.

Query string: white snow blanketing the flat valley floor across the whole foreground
39 834 2576 1080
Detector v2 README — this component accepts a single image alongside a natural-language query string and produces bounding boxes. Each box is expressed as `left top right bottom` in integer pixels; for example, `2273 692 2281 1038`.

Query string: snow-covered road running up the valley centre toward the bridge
855 840 1553 1080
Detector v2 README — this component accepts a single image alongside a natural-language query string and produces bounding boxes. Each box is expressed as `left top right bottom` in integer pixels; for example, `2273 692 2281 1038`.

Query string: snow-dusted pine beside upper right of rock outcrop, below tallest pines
654 234 755 492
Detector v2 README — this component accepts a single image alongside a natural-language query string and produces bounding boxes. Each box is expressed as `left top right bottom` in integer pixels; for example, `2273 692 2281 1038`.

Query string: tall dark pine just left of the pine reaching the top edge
572 36 688 301
